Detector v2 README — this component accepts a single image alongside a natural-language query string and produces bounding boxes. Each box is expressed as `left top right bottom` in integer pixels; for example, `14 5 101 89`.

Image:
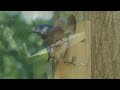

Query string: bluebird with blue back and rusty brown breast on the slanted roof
33 24 64 61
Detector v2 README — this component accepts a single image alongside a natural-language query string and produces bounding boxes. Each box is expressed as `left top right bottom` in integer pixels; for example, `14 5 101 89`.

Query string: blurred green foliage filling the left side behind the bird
0 11 54 79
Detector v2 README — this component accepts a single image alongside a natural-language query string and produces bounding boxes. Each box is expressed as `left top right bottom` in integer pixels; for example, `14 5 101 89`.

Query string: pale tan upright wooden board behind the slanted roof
54 21 91 79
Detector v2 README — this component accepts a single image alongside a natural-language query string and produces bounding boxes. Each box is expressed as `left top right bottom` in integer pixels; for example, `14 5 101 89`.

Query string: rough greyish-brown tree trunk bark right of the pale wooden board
85 11 120 79
